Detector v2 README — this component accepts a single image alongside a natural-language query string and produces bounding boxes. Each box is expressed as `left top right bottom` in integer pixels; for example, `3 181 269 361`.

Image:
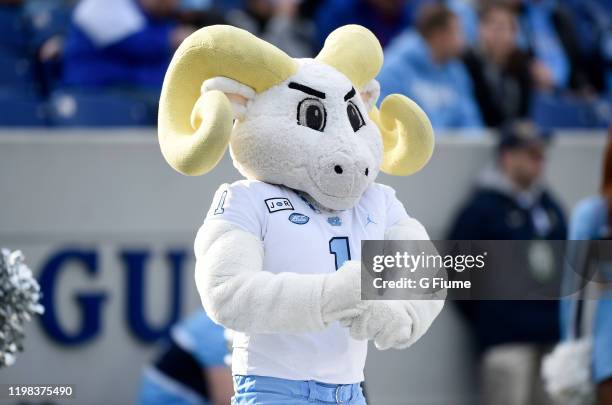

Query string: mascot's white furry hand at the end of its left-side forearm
321 260 366 325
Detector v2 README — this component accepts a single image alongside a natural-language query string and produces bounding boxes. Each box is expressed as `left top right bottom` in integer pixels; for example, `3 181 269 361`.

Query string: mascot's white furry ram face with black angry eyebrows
230 59 383 210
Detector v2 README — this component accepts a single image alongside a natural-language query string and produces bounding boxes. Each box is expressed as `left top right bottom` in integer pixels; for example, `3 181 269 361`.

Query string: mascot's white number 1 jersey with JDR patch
205 180 408 384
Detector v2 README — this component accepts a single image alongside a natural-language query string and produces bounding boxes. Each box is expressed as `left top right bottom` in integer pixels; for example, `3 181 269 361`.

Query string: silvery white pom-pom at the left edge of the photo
0 249 44 368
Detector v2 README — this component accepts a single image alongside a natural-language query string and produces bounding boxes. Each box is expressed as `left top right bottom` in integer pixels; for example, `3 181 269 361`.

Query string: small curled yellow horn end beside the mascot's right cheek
370 94 434 176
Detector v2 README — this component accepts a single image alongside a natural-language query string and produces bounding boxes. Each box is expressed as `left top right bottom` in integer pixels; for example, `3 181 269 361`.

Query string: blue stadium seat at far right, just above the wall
531 95 611 130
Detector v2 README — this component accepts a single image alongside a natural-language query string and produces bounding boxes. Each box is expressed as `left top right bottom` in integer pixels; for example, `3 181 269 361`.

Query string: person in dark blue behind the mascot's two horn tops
315 0 420 49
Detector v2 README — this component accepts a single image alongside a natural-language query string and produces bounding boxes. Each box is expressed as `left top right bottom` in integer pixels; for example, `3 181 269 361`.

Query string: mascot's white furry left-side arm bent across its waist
195 221 361 333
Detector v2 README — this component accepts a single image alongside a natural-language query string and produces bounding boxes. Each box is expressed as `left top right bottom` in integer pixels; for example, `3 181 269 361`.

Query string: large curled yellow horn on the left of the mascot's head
158 25 297 175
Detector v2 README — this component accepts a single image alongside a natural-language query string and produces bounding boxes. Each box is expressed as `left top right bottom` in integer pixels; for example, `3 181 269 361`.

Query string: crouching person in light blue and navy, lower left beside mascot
137 310 233 405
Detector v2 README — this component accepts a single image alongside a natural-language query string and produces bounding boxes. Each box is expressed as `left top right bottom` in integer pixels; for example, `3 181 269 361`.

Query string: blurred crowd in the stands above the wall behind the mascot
0 0 612 129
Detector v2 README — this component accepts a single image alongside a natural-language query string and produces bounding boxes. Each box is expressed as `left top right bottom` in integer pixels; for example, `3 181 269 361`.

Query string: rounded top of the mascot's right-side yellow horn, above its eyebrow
316 25 383 90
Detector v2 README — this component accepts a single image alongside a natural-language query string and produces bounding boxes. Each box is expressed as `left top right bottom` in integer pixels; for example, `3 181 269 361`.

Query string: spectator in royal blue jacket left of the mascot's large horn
63 0 194 91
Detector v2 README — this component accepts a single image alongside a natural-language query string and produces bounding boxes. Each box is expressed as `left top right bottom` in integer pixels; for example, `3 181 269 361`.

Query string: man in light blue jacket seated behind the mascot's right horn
378 4 482 129
